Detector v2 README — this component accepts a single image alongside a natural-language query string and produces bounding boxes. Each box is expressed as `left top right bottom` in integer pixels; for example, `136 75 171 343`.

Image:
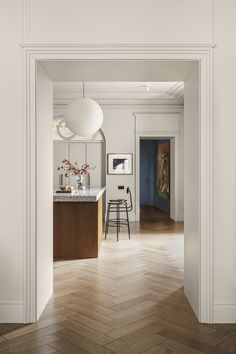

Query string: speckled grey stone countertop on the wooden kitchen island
53 187 106 202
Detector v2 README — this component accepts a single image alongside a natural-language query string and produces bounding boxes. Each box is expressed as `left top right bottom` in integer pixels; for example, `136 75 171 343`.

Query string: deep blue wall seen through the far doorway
140 139 170 214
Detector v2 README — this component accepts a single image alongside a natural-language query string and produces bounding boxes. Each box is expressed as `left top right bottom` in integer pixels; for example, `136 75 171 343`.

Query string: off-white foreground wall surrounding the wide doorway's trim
0 0 236 322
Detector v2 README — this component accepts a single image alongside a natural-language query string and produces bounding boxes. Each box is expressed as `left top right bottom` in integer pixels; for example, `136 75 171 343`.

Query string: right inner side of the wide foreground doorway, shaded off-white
184 64 201 317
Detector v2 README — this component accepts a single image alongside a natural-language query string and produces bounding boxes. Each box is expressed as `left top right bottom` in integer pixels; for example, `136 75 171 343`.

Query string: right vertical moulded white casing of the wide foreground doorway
199 50 213 323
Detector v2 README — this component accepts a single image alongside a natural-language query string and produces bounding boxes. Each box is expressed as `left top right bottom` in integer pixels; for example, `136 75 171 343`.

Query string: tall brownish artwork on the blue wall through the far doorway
157 143 170 199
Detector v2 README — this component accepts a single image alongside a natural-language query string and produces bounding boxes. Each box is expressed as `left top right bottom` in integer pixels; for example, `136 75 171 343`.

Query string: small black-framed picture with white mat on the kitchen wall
107 154 133 175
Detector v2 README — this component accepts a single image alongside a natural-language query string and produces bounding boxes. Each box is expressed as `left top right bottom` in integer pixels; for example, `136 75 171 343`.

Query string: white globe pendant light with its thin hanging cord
64 83 103 137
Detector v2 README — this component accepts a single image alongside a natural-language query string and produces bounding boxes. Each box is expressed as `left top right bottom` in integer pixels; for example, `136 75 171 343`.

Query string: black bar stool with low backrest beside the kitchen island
105 187 133 241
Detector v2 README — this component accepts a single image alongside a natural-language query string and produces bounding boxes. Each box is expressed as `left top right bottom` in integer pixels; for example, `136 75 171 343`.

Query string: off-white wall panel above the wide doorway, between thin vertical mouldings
29 0 212 44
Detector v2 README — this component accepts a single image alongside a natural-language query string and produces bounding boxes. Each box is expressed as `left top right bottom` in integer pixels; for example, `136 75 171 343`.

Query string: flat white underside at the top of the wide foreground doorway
40 59 196 82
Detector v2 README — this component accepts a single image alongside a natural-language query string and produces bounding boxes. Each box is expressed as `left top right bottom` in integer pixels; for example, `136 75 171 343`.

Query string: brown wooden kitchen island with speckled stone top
53 188 105 260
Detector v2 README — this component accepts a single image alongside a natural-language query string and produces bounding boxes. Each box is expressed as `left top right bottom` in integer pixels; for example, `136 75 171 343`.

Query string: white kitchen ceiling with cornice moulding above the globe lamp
54 82 184 105
